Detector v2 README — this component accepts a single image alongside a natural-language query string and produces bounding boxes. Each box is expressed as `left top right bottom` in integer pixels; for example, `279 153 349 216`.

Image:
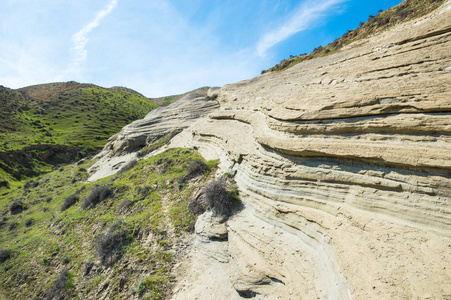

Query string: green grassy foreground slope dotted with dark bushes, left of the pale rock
0 149 217 299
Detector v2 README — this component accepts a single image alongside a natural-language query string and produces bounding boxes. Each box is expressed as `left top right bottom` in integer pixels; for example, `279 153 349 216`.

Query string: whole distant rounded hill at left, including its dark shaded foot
0 81 158 178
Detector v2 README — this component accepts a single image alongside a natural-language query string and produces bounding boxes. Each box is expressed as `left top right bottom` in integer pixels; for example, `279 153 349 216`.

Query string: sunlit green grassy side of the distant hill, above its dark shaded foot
0 84 157 151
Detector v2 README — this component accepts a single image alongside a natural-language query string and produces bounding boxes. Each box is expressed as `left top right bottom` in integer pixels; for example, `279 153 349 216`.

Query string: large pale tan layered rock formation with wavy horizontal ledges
89 1 451 299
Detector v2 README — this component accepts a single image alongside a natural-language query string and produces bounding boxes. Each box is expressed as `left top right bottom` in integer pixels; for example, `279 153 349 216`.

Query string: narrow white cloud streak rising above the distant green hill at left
58 0 118 80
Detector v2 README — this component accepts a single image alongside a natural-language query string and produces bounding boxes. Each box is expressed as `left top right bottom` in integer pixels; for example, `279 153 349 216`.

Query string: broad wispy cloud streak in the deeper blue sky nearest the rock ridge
257 0 347 57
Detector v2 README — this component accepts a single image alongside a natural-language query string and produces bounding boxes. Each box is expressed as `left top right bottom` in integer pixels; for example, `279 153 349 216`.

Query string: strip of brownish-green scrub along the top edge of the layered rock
262 0 445 74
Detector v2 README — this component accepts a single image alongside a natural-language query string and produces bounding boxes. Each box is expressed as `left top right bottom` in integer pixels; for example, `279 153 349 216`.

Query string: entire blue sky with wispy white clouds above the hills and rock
0 0 401 97
